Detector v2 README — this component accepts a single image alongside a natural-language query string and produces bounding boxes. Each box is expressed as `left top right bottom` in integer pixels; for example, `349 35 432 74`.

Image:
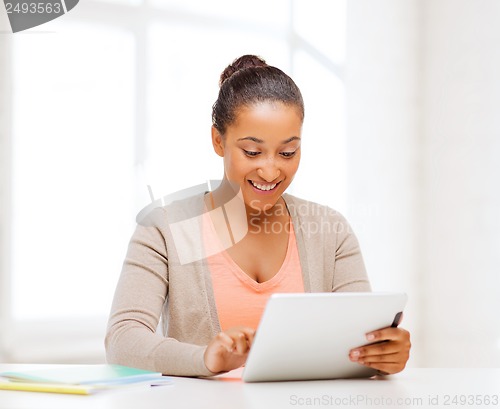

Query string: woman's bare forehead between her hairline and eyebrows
227 101 302 139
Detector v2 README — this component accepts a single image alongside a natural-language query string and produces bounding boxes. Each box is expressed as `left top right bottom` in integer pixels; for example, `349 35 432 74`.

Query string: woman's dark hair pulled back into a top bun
212 55 304 135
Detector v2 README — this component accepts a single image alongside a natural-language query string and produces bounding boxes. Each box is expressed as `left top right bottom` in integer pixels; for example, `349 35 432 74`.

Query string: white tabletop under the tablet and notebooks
0 364 500 409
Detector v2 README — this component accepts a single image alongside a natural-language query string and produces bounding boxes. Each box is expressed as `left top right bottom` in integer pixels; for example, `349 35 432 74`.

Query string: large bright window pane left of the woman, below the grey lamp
12 22 134 319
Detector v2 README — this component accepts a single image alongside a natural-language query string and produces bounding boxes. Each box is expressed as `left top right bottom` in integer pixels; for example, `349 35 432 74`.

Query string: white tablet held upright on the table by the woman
242 292 407 382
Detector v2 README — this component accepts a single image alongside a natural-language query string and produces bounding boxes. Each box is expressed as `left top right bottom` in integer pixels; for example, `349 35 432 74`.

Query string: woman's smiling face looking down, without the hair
212 102 302 211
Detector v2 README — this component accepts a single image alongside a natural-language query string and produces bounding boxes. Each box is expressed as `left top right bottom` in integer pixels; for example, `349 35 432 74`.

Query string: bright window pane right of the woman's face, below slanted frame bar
293 51 347 211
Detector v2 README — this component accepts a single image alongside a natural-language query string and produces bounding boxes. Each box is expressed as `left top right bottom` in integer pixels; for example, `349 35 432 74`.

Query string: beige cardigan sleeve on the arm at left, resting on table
105 208 214 376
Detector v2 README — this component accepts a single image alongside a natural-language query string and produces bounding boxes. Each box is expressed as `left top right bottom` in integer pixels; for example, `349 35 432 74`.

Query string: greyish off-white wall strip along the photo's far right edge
421 0 500 366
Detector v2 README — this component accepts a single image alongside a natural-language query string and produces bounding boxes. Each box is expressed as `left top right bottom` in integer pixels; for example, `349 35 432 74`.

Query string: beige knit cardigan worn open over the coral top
105 194 370 376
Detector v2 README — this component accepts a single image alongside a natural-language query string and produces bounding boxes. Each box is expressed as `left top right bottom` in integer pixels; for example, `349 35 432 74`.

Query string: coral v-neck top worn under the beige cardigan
203 217 304 331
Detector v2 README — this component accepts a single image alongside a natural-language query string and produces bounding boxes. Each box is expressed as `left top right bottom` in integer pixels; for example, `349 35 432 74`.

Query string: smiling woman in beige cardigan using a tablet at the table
106 55 410 376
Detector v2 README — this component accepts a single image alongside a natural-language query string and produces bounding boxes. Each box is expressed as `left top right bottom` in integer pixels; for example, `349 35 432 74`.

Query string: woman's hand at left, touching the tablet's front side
204 327 255 373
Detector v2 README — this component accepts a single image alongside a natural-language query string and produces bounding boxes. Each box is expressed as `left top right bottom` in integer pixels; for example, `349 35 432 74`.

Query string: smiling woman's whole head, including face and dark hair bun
212 55 304 215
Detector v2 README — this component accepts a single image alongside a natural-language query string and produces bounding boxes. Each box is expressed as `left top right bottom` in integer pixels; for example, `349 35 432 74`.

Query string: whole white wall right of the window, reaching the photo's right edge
346 0 500 367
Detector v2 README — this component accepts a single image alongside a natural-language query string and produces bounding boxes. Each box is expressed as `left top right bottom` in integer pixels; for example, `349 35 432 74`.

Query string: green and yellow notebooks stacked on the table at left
0 365 171 394
